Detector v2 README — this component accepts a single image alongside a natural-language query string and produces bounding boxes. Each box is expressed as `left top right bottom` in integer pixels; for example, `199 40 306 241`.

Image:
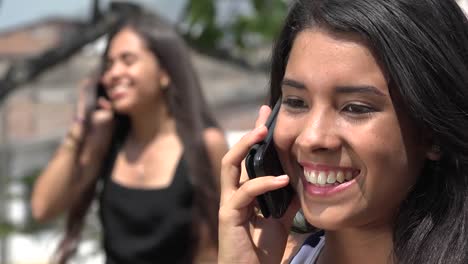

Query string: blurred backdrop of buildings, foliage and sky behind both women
0 0 468 264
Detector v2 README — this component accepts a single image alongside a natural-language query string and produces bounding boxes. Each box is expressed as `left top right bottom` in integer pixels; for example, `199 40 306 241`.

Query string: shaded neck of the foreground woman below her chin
317 227 395 264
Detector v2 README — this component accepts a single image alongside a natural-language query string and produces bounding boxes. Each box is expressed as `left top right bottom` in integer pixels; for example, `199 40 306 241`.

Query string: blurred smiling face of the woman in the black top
101 27 169 114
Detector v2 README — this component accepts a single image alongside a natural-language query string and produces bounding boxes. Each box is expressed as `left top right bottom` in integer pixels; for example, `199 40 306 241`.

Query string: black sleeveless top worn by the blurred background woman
100 157 193 264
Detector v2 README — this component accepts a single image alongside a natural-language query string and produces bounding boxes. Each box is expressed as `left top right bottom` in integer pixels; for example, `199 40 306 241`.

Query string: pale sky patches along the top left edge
0 0 184 32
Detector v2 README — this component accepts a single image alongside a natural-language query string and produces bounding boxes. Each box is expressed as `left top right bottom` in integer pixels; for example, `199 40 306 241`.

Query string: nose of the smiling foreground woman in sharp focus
296 111 342 151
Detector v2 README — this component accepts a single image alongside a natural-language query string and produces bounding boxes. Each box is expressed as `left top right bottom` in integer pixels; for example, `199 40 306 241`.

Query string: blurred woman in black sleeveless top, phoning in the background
32 10 227 263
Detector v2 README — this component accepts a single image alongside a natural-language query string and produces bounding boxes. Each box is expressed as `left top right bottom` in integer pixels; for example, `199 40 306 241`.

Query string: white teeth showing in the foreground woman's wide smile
304 168 360 187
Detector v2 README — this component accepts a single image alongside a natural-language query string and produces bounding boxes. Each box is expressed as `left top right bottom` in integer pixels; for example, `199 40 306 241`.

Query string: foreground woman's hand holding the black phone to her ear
218 106 299 263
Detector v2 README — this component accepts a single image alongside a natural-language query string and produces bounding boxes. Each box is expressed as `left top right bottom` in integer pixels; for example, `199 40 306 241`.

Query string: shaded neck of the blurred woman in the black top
129 98 176 144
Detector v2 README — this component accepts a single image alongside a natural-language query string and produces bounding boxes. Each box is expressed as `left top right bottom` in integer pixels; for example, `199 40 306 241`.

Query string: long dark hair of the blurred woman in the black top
57 10 219 263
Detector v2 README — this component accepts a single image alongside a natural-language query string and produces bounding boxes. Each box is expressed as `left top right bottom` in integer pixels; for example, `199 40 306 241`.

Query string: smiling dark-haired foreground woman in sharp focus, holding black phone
219 0 468 264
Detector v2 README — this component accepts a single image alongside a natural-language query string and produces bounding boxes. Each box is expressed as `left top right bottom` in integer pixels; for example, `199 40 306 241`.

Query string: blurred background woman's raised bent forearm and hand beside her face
31 96 113 221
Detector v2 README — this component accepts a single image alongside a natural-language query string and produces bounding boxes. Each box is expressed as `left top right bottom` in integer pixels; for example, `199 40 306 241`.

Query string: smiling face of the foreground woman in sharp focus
274 30 427 230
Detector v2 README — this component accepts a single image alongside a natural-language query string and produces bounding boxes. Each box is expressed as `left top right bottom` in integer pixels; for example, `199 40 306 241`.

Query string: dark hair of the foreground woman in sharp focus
270 0 468 264
